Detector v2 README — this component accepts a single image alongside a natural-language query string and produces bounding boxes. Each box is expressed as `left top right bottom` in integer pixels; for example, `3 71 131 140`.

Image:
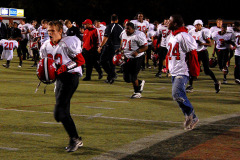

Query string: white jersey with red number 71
120 30 148 58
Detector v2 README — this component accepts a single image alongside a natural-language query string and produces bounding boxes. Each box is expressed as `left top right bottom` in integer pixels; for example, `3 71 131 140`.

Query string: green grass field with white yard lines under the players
0 48 240 160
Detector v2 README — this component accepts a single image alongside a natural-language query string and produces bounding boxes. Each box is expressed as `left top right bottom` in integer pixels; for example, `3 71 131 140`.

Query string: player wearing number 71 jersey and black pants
119 22 148 98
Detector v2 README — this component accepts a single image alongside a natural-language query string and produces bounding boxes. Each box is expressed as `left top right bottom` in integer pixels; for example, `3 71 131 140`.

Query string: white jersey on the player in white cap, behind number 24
188 28 211 51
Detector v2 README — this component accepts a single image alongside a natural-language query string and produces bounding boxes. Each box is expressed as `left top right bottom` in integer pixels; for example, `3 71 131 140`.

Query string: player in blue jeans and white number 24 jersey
167 15 200 130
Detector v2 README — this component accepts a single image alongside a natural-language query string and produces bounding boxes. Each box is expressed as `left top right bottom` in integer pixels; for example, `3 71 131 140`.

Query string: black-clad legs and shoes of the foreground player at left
54 73 82 152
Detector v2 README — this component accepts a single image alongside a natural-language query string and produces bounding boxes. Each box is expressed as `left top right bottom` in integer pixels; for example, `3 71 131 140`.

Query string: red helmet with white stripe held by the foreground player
37 58 56 84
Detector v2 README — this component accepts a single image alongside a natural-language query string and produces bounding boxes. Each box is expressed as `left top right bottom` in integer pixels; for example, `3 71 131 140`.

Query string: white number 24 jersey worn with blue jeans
167 32 197 76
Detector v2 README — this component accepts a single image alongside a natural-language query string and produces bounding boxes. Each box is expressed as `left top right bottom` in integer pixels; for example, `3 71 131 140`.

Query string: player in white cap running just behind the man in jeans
186 19 220 93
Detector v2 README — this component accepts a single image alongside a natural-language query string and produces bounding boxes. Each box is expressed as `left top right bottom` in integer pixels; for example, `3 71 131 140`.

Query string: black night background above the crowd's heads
0 0 240 25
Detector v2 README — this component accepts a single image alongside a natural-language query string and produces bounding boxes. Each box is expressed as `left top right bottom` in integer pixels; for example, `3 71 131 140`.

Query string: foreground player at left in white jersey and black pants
40 21 85 152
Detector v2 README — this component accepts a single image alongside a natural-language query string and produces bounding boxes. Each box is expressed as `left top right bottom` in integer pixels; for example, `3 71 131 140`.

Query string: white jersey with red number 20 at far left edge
0 39 18 60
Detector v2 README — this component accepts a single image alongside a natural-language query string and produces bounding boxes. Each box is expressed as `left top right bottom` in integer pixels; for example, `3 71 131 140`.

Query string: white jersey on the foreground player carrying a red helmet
40 36 82 76
